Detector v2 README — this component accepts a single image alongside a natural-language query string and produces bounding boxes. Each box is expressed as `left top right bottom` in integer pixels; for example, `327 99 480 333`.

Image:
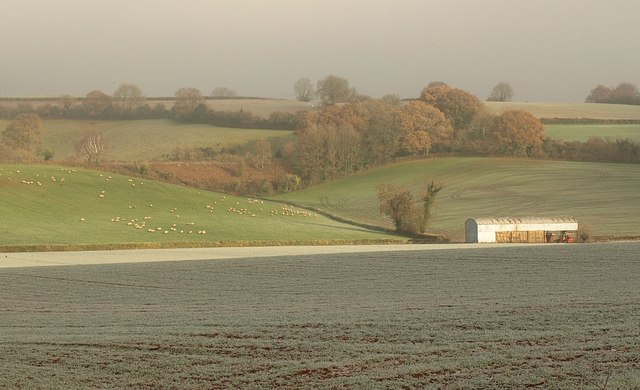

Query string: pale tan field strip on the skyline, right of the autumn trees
484 102 640 120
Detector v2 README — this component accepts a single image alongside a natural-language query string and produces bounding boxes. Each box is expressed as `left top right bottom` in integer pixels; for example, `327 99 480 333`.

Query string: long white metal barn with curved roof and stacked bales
465 217 578 243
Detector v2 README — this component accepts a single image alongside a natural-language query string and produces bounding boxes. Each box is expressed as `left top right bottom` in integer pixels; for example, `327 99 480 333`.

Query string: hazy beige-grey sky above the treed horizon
0 0 640 102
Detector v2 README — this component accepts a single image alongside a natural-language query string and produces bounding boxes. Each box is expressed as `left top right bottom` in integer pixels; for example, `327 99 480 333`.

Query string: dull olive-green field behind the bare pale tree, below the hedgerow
0 119 292 161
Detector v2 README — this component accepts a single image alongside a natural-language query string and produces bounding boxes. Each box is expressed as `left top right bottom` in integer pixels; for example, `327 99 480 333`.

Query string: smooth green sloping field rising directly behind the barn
278 158 640 240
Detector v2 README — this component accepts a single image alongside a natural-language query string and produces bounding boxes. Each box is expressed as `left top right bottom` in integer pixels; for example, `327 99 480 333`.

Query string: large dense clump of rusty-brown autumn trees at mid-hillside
282 83 546 184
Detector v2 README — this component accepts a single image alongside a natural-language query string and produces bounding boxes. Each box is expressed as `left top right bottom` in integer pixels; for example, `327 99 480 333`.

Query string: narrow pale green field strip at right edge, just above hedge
545 124 640 143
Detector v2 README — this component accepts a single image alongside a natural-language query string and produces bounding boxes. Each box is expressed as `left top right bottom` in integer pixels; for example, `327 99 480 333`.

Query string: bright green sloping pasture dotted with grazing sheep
0 165 400 245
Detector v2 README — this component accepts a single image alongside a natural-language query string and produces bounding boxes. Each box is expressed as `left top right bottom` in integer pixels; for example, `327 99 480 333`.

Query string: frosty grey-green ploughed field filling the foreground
0 242 640 389
